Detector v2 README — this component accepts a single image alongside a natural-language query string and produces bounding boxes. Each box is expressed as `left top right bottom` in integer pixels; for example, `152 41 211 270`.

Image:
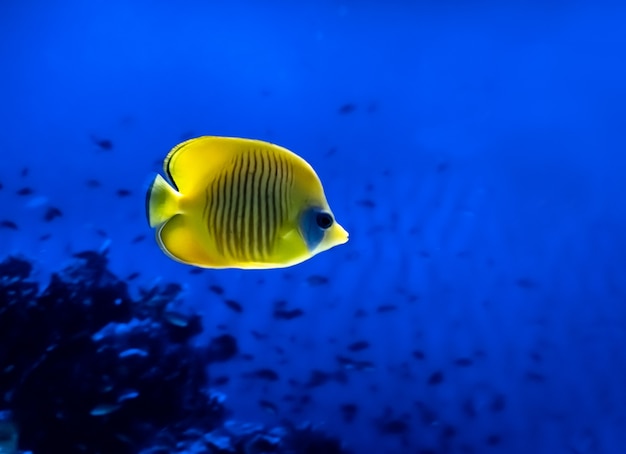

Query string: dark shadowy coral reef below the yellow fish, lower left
0 250 347 454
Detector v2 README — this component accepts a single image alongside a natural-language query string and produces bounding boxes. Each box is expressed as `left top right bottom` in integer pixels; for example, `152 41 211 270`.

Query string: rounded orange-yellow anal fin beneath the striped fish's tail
156 214 223 268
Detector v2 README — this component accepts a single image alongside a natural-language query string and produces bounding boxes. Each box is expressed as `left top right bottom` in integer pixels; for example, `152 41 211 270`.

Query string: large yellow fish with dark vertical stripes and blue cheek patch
146 136 348 269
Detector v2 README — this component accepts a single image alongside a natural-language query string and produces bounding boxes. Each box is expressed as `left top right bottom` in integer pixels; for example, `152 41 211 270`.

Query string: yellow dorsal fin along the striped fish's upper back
163 136 280 196
